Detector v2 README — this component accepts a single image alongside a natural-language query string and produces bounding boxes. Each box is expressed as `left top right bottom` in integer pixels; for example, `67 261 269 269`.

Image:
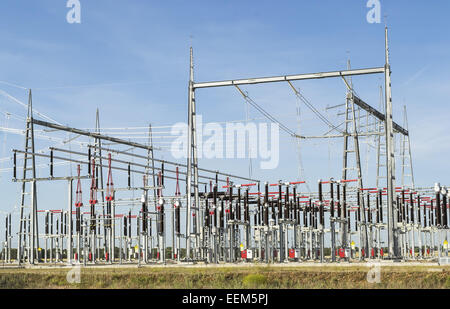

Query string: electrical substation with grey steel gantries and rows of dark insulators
0 28 450 266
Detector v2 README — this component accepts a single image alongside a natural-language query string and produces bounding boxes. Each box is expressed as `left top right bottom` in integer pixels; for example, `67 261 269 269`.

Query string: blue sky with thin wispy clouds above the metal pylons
0 0 450 231
